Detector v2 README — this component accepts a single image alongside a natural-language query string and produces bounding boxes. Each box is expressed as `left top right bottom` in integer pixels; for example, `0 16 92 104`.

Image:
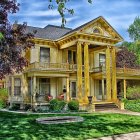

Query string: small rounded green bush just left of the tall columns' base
68 100 79 111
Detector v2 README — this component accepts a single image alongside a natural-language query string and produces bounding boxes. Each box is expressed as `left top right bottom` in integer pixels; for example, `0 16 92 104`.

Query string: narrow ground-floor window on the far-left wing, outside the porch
14 78 21 95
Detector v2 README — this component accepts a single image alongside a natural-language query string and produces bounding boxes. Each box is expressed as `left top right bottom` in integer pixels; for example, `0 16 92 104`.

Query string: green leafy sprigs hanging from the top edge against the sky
48 0 92 27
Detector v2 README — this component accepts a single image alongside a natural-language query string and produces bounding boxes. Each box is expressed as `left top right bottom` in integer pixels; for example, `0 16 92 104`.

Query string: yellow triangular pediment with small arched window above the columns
78 17 123 41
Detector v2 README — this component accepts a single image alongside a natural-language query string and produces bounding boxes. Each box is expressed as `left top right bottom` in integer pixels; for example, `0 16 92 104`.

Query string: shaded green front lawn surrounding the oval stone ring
0 112 140 140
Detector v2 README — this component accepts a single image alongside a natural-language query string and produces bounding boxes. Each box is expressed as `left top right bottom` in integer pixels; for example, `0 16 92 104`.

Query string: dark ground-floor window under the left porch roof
39 78 50 95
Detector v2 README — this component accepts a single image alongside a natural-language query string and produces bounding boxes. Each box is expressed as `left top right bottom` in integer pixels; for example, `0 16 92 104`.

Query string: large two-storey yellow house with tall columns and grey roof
7 16 140 109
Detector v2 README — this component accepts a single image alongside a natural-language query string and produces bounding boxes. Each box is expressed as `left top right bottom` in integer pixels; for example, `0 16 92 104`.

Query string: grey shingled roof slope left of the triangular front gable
26 25 72 40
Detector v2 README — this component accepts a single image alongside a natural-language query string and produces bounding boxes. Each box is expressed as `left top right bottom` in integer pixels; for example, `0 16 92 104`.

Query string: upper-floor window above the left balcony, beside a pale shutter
40 47 50 63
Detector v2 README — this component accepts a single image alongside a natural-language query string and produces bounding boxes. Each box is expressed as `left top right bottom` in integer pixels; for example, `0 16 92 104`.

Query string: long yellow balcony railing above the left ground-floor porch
26 62 77 72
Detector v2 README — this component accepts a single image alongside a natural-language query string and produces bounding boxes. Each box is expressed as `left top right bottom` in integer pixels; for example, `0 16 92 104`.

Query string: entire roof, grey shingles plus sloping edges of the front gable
26 16 123 40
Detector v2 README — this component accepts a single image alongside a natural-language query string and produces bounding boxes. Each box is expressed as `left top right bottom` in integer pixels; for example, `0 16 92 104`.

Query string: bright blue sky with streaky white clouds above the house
9 0 140 41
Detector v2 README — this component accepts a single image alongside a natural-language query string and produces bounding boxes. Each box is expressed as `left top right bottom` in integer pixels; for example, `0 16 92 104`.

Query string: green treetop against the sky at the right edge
128 17 140 41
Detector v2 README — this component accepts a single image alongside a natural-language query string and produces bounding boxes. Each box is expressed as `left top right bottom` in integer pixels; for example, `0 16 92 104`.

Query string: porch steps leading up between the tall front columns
95 103 118 111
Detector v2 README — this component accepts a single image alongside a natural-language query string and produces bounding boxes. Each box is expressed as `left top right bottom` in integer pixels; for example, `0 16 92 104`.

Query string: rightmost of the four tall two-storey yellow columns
112 47 117 101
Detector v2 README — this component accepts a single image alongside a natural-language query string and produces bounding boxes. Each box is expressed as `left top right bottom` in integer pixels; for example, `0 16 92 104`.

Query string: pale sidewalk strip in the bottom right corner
88 132 140 140
